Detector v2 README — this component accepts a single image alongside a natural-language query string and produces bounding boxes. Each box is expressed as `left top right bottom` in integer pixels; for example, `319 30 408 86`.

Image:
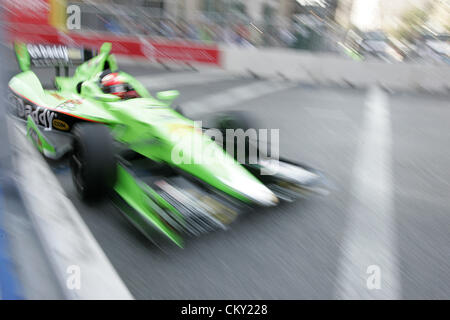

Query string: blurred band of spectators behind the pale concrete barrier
71 0 449 63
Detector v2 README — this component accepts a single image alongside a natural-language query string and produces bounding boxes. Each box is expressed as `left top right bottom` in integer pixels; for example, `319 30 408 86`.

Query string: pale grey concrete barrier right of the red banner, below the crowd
220 46 450 93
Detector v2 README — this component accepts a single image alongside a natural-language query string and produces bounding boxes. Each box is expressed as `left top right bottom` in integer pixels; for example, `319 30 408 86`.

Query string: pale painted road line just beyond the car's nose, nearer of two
182 81 297 114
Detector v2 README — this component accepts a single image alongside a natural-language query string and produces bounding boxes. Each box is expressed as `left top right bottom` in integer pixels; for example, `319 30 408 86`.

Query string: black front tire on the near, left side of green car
70 123 117 201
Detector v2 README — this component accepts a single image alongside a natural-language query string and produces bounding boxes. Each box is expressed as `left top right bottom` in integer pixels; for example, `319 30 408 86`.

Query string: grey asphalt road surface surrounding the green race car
33 67 450 299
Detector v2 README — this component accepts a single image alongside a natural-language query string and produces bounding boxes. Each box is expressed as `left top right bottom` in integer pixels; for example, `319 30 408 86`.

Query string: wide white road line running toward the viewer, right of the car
335 87 401 299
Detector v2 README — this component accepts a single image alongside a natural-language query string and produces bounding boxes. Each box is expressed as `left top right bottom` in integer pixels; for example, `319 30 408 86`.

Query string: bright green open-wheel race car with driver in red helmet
9 43 326 247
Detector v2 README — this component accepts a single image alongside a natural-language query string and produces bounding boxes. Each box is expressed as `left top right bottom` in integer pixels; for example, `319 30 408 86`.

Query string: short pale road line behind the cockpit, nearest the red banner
136 70 236 90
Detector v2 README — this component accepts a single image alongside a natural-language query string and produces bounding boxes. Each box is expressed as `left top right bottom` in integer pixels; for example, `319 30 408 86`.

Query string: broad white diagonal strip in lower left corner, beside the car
8 119 133 300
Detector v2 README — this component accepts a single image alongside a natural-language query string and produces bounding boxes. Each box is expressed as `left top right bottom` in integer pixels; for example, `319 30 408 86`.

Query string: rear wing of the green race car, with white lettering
14 42 97 76
